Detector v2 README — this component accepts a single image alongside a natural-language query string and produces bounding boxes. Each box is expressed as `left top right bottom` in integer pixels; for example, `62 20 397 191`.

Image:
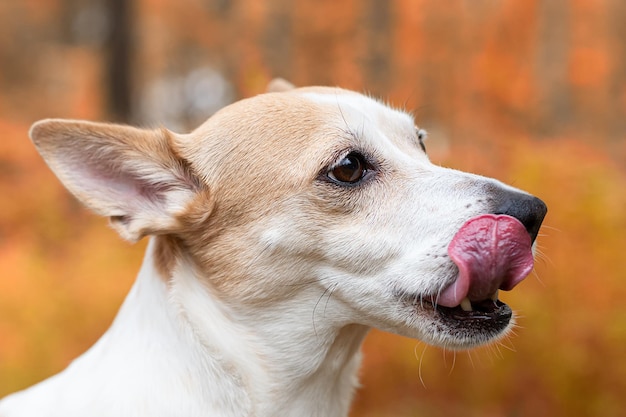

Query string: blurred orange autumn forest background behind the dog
0 0 626 417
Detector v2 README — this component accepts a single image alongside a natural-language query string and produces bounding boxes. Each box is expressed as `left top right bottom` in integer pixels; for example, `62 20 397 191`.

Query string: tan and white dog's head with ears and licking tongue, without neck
31 79 546 348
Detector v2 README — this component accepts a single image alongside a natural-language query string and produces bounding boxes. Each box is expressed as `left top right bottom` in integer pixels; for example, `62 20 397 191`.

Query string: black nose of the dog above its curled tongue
494 191 548 242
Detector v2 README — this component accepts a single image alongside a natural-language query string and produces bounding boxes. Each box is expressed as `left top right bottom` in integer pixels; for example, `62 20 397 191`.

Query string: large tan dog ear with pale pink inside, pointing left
30 119 199 241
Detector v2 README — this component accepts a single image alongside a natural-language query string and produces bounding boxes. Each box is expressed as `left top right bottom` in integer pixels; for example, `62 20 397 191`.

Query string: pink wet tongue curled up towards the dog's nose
437 214 533 307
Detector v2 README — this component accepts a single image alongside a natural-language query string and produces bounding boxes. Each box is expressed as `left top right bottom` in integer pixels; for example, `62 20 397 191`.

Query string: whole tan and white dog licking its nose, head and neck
0 80 547 417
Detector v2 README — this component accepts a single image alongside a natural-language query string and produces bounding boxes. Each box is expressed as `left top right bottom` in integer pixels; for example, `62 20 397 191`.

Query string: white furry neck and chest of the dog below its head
0 237 368 417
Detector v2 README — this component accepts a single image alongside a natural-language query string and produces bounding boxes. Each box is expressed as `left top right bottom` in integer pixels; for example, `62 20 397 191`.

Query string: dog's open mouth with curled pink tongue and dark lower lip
401 214 534 348
